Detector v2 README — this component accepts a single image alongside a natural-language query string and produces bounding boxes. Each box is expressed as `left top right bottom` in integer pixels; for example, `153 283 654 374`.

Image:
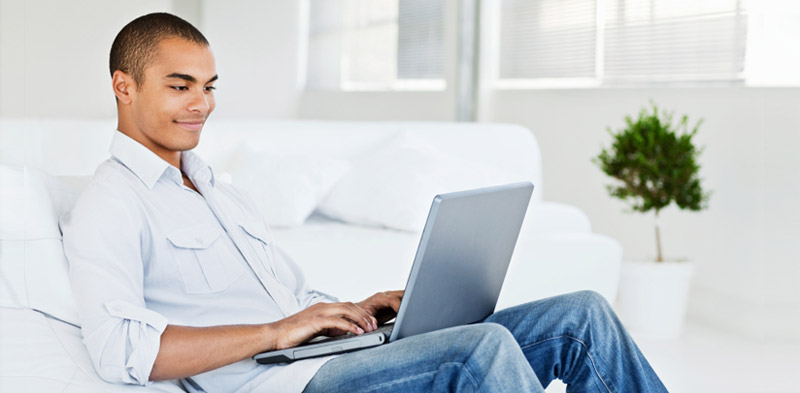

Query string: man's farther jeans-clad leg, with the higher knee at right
485 291 667 393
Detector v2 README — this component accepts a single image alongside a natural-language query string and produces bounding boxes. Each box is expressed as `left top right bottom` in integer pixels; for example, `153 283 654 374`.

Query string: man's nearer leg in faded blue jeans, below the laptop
304 323 544 393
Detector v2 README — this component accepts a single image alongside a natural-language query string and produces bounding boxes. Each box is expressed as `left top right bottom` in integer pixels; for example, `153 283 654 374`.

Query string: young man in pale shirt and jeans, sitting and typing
64 13 666 393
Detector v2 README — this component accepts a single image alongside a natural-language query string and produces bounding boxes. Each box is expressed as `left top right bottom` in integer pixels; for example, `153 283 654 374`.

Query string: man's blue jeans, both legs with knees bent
304 291 667 393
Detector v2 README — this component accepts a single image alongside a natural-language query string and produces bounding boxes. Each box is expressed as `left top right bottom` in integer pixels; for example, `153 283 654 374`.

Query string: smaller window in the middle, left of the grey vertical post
306 0 445 91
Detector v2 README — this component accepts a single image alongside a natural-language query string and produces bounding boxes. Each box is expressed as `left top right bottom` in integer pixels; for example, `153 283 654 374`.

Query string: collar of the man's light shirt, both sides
108 130 214 189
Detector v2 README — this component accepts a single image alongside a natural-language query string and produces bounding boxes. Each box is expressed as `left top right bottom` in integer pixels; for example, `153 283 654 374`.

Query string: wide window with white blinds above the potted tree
498 0 747 87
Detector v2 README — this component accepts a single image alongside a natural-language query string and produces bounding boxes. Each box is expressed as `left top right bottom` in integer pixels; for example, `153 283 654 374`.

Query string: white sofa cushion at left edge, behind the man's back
0 165 79 325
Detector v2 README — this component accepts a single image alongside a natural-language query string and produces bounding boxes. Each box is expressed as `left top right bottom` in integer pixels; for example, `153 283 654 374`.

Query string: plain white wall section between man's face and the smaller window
201 0 301 118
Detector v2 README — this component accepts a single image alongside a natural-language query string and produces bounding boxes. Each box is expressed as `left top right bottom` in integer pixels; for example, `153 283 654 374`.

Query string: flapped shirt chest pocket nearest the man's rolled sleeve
167 224 244 294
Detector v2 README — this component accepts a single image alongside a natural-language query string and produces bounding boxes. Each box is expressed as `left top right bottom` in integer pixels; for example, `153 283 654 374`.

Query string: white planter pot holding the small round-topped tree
617 261 694 338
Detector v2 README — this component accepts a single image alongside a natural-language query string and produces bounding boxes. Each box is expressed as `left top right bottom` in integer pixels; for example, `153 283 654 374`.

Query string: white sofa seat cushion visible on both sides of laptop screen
273 213 622 309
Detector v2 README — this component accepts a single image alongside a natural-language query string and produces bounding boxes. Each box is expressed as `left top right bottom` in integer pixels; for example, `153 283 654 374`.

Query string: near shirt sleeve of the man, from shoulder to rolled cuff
62 185 167 385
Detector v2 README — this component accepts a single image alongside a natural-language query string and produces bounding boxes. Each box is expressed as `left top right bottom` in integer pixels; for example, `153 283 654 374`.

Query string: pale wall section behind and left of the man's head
0 0 199 118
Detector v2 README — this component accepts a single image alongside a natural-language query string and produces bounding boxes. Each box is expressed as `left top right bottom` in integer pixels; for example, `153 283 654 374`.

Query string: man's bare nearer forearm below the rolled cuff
150 324 275 381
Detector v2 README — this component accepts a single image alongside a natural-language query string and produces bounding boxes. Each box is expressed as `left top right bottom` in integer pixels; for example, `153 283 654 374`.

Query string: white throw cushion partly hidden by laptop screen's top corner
319 131 528 231
